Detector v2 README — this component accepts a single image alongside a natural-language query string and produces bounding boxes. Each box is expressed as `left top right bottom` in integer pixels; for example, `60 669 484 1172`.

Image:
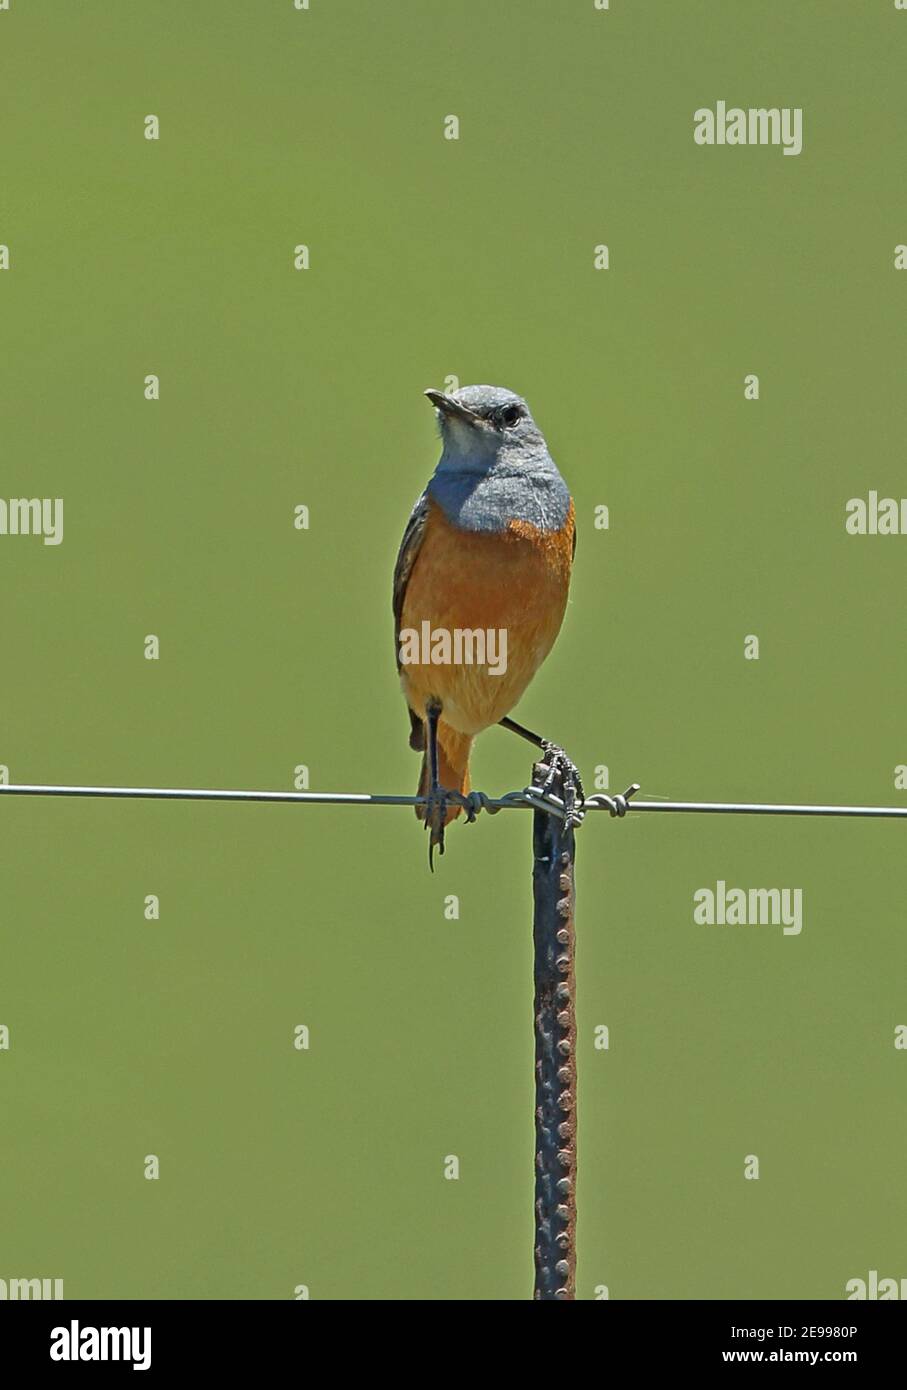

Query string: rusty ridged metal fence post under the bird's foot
532 763 576 1300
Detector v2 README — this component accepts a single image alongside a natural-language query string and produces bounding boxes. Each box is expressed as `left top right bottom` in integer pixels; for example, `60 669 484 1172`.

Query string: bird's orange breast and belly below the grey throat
400 502 574 734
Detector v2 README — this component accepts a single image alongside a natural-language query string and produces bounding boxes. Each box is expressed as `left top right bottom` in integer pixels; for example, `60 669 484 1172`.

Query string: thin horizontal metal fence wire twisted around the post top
0 783 907 819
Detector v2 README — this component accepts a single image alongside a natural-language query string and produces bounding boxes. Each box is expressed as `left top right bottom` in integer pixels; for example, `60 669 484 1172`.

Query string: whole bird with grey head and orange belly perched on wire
393 385 583 869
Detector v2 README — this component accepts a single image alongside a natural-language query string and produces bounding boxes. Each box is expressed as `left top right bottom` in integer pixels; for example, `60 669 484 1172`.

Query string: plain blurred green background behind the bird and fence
0 0 907 1300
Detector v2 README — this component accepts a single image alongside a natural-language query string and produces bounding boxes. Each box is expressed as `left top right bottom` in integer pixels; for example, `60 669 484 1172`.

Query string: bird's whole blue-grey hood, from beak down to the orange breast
425 386 569 531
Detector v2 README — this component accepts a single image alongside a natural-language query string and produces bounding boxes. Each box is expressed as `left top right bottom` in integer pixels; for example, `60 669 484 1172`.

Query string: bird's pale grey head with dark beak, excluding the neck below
425 386 547 473
